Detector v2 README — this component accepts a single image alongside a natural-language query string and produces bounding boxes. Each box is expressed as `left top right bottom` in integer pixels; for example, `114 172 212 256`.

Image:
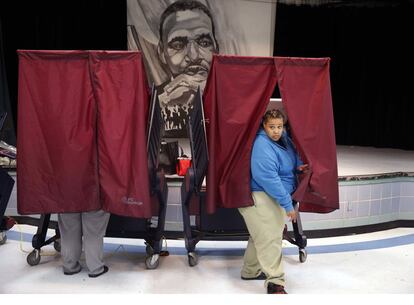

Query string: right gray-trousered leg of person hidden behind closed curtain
82 210 110 277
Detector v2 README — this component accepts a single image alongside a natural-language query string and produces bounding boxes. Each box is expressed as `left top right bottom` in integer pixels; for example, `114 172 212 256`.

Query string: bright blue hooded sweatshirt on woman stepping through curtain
250 128 303 212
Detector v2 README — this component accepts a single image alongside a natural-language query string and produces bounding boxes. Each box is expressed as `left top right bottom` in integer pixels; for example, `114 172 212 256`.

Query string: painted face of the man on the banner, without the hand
161 10 217 78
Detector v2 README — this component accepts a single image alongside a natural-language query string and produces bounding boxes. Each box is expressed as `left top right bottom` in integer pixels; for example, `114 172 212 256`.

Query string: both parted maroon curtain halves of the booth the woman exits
204 55 339 213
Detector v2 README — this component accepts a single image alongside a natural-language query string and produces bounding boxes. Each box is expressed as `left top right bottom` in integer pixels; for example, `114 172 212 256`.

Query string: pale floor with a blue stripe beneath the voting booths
0 225 414 294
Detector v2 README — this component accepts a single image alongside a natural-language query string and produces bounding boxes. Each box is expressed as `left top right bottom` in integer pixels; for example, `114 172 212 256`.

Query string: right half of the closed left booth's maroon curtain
91 52 151 218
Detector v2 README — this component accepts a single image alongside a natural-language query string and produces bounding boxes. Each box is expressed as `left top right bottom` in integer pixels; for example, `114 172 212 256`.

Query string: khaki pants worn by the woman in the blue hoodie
239 192 286 287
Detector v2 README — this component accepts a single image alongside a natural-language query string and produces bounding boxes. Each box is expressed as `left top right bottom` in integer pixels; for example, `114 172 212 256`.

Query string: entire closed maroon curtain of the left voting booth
17 51 151 218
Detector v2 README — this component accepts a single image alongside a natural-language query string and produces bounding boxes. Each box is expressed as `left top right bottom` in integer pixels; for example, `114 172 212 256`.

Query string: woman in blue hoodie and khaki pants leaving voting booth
239 110 308 294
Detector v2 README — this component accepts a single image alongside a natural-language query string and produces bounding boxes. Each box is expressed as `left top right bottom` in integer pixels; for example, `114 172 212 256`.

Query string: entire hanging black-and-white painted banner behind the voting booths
127 0 276 137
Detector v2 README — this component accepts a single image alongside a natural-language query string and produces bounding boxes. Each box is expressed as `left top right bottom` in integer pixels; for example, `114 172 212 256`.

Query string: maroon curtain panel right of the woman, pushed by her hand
275 57 339 213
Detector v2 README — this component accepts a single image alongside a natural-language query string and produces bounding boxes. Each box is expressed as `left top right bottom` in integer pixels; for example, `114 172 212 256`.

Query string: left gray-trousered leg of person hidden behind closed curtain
58 213 82 275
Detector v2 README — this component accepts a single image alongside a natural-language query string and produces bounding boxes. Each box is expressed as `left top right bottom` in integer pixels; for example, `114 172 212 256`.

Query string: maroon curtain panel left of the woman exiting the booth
204 55 276 213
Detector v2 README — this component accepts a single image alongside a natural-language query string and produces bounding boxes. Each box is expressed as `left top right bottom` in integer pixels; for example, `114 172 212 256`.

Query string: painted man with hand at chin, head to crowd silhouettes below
157 1 219 134
